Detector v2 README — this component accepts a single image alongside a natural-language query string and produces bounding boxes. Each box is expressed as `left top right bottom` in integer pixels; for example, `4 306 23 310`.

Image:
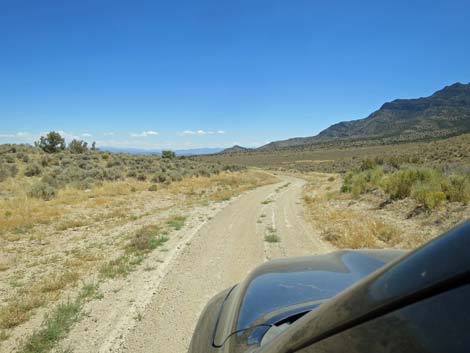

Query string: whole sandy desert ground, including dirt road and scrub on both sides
0 140 470 353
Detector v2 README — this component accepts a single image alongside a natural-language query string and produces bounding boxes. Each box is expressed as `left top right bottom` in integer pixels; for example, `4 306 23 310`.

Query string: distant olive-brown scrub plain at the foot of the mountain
198 134 470 173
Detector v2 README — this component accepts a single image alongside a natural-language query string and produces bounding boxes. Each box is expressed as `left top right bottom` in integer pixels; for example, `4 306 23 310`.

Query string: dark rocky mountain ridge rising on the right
259 83 470 150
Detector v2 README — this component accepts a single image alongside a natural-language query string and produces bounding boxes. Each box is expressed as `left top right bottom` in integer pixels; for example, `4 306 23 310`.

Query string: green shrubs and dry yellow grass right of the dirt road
302 168 470 249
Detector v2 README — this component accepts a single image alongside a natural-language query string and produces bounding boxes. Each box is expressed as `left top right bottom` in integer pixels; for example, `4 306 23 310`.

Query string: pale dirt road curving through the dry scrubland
62 176 332 353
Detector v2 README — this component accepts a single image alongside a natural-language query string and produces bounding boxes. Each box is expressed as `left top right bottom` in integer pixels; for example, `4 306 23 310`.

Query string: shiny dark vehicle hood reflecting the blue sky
214 250 405 351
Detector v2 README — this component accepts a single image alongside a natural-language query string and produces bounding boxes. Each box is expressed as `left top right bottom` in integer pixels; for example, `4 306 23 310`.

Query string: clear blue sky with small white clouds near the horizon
0 0 470 149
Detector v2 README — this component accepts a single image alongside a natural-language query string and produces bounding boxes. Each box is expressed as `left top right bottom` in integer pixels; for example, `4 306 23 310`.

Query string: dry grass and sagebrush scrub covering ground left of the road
0 136 275 352
